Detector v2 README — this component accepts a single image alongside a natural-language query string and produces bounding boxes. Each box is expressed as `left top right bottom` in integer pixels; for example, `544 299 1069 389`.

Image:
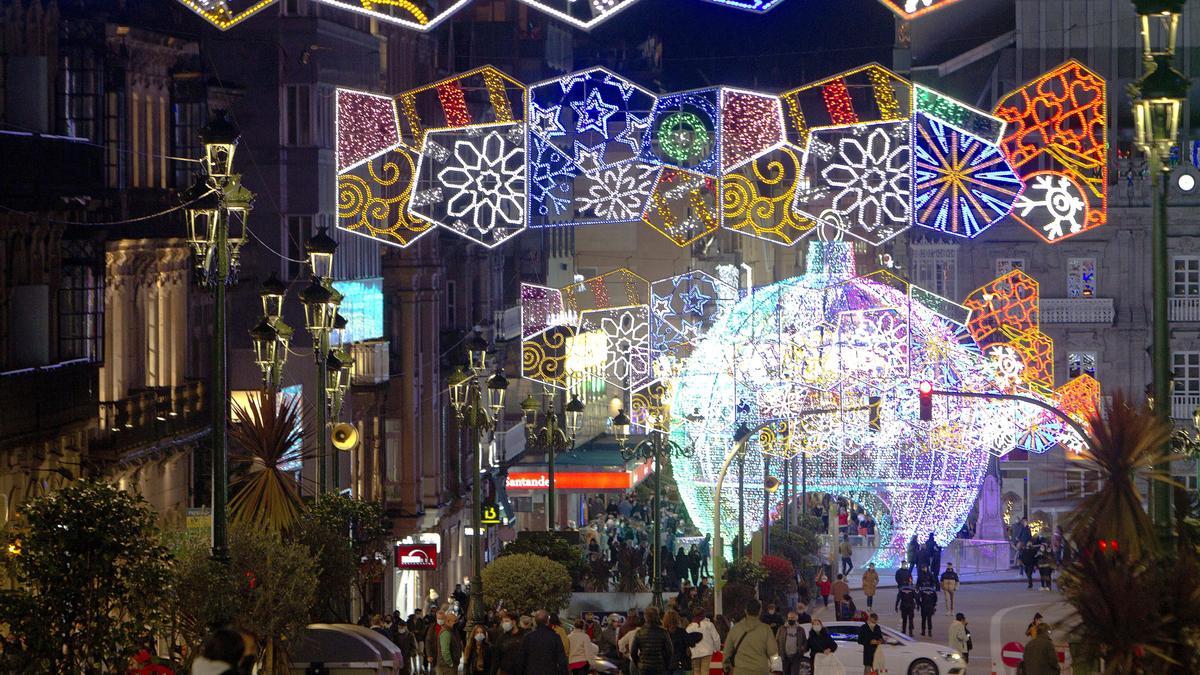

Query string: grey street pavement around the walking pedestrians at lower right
814 569 1069 675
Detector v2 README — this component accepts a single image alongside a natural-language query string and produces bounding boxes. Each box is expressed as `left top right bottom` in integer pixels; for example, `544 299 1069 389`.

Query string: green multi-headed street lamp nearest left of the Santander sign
450 329 509 623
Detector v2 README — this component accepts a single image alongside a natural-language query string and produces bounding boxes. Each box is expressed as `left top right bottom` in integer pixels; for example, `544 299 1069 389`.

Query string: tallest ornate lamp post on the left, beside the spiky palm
186 110 254 561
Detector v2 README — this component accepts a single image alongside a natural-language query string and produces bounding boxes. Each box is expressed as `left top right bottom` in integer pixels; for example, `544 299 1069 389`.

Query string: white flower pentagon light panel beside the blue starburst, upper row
793 121 912 245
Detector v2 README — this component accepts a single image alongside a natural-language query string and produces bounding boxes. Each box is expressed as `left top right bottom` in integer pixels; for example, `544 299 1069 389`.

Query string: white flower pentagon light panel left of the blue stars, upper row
408 124 526 249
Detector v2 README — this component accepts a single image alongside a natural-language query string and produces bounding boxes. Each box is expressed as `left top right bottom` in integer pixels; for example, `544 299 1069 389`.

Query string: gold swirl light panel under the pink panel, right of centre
721 145 815 246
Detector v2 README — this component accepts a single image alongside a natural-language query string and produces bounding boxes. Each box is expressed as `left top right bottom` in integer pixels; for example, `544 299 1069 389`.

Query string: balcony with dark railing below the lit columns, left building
91 381 210 460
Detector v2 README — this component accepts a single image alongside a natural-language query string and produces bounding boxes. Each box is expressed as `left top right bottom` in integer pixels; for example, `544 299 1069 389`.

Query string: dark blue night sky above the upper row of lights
590 0 895 91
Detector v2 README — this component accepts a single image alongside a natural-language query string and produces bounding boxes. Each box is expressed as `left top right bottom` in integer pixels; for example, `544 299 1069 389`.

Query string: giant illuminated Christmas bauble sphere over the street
671 241 1038 566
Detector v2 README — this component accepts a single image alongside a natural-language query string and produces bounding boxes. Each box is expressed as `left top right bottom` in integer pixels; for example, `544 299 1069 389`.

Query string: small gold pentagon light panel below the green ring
642 168 721 247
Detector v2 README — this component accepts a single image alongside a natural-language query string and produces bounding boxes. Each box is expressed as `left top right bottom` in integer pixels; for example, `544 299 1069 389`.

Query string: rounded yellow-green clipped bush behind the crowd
484 554 571 614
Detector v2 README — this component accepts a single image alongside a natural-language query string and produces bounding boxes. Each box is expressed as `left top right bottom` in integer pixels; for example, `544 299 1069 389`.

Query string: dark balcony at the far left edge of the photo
0 359 100 446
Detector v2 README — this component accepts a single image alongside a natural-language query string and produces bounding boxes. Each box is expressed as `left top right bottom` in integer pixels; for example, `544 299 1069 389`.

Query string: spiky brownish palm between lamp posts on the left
229 392 305 533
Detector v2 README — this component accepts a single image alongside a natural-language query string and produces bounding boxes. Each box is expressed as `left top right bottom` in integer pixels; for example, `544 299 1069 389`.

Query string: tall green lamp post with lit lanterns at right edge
1129 0 1188 526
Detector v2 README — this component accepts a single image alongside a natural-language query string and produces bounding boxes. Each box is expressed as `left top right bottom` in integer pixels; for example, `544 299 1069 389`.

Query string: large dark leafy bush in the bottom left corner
0 480 172 673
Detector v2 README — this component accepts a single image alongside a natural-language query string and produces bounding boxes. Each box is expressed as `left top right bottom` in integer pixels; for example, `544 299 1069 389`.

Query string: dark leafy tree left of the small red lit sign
295 492 389 621
